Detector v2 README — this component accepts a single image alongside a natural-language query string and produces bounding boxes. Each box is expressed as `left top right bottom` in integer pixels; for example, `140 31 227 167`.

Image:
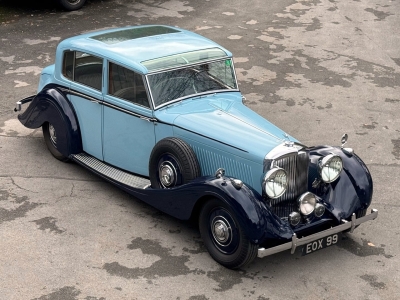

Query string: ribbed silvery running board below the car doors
70 153 150 189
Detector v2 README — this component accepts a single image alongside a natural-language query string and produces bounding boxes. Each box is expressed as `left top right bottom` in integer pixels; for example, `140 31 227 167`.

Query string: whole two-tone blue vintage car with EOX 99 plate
15 25 378 268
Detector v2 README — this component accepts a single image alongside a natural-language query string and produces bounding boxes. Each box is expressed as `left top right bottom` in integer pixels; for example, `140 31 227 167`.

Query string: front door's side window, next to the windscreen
108 62 150 107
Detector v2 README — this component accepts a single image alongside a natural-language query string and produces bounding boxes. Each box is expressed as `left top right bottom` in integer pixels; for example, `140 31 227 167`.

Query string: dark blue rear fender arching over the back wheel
18 86 82 157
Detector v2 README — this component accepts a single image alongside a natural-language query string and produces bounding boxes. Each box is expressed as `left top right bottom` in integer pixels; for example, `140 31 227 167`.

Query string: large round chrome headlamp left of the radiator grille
262 167 288 199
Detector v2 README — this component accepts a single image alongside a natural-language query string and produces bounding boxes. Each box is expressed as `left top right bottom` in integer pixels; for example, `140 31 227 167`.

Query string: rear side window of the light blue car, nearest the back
62 51 103 91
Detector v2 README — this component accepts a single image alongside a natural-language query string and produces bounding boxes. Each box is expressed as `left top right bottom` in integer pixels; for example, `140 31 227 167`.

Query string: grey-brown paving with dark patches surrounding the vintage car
0 0 400 300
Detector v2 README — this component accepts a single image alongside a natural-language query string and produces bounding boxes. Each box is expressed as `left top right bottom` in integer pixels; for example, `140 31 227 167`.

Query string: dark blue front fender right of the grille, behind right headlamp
309 146 373 219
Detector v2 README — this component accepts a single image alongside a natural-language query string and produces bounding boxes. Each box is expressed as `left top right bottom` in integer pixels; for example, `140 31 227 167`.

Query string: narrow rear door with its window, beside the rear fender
63 51 104 160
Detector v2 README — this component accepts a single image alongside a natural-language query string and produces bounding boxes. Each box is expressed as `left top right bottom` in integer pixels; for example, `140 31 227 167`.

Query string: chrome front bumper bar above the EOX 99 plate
257 209 378 257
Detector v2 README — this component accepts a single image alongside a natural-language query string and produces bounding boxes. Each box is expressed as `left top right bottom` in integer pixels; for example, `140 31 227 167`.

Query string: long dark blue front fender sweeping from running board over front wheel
79 159 293 244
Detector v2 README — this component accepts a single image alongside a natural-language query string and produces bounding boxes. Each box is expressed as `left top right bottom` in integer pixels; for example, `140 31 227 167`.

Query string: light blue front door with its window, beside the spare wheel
103 62 155 176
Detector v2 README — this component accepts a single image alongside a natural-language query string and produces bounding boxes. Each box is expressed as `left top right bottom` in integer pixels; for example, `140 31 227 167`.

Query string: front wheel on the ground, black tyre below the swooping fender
199 199 258 269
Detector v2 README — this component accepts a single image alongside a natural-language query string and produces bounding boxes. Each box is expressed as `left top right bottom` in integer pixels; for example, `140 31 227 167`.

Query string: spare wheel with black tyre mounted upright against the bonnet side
149 138 200 189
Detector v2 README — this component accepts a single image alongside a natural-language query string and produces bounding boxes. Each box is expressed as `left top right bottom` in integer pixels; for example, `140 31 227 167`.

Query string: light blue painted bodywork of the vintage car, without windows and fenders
38 26 296 194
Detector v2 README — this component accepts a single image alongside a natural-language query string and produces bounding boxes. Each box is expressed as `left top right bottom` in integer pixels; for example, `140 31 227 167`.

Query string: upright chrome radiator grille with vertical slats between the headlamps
268 151 309 218
